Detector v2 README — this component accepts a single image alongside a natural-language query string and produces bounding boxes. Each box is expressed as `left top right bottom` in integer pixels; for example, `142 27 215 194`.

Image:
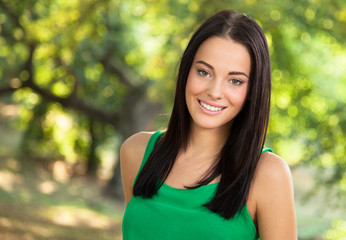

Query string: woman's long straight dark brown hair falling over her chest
133 10 271 219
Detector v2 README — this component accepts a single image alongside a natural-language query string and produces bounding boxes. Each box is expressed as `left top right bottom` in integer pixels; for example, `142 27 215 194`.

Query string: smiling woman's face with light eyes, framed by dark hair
185 36 251 130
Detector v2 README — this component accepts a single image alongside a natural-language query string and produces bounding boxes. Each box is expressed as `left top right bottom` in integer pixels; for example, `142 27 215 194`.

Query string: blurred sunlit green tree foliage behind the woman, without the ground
0 0 346 210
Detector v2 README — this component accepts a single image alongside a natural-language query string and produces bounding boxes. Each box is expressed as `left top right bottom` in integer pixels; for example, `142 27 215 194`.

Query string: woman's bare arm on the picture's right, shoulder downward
254 152 297 240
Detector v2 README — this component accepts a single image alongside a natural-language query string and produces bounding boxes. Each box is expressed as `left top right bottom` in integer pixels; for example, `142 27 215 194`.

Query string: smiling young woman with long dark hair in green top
120 11 296 240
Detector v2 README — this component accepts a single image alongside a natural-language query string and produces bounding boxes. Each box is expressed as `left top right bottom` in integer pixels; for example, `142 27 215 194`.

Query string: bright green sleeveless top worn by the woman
122 131 272 240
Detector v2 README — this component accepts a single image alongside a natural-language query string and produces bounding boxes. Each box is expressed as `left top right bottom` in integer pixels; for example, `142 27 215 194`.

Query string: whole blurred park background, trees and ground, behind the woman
0 0 346 240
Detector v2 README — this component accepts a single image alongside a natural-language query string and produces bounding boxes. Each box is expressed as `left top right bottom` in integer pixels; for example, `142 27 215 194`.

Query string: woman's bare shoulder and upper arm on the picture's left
120 132 154 203
